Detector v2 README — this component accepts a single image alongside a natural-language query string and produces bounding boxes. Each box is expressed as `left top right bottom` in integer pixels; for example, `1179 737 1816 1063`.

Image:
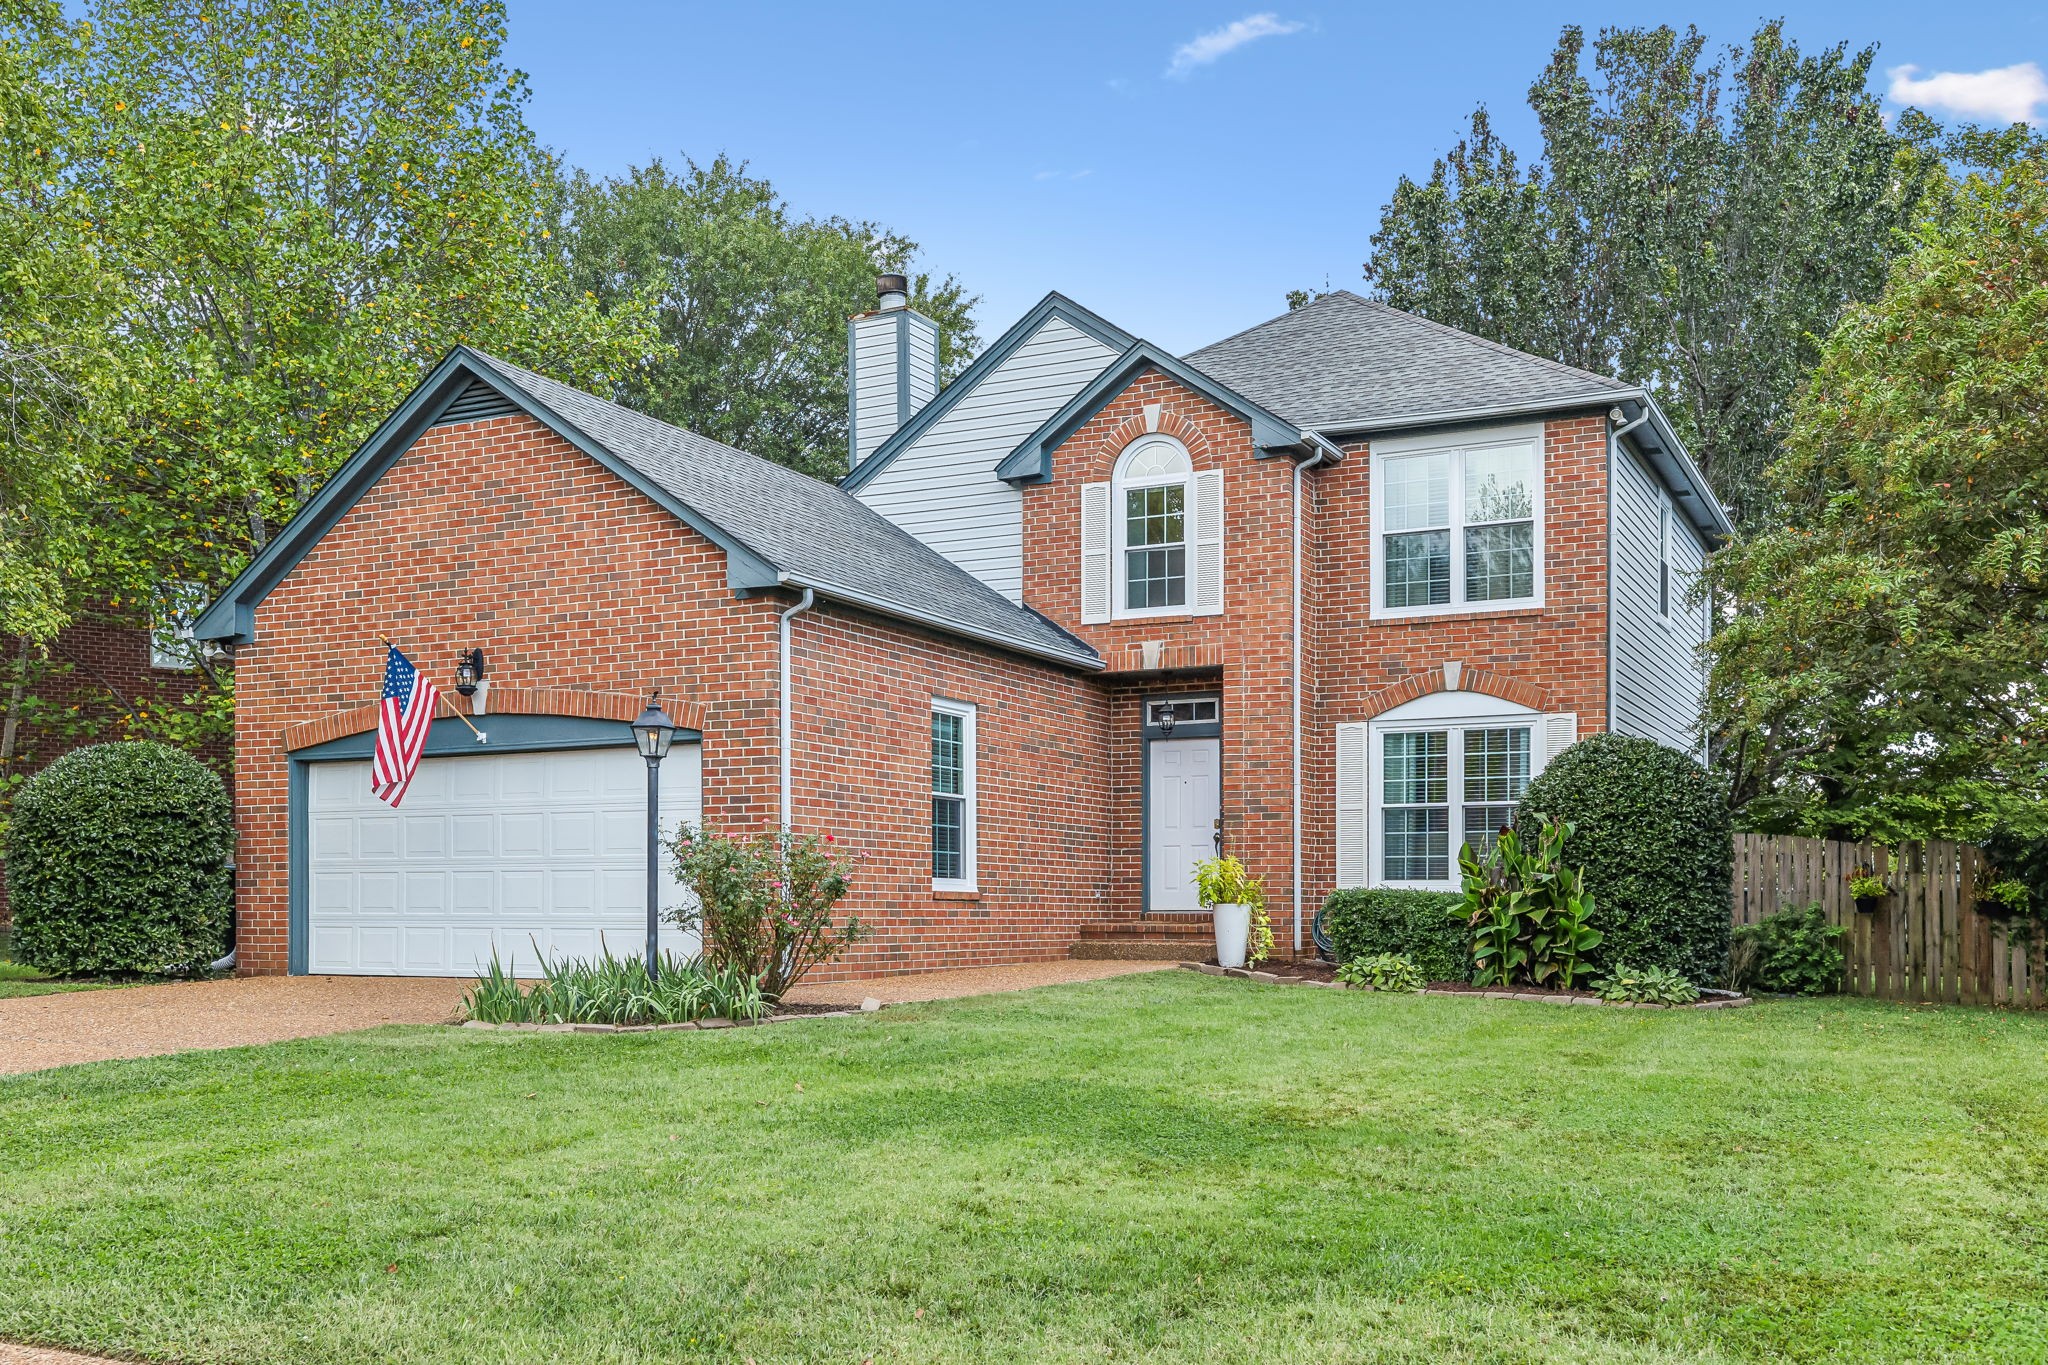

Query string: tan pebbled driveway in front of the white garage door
0 976 469 1074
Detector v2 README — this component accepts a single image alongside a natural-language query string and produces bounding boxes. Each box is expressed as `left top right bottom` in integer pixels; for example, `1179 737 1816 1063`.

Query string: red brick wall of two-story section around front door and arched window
1024 372 1608 952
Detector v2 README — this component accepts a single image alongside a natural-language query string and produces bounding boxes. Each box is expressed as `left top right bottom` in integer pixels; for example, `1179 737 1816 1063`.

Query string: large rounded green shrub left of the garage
6 741 236 974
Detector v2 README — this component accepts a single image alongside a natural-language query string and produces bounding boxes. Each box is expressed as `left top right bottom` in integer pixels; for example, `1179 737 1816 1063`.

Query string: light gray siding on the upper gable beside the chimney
858 317 1116 602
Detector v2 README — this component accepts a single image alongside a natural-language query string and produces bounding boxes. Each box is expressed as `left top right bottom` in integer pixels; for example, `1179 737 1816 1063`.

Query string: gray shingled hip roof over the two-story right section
1186 291 1636 430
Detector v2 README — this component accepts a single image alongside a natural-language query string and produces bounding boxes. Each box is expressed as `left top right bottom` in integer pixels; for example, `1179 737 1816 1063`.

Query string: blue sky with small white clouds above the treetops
508 0 2048 350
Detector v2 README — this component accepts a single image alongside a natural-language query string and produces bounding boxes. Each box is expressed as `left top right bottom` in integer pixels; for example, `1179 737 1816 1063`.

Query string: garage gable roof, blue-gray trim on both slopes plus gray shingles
197 346 1102 669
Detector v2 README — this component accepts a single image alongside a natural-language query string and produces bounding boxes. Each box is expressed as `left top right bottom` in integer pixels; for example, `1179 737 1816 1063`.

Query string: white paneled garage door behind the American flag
305 743 702 976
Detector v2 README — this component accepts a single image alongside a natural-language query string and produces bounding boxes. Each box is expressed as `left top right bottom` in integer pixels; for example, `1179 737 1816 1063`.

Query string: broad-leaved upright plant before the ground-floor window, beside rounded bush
1458 821 1602 990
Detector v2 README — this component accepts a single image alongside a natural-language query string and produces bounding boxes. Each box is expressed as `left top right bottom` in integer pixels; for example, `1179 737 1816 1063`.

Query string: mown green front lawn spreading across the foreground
0 972 2048 1365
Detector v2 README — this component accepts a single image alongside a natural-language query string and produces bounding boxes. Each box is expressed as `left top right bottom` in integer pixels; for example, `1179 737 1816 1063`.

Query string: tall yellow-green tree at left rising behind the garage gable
61 0 651 650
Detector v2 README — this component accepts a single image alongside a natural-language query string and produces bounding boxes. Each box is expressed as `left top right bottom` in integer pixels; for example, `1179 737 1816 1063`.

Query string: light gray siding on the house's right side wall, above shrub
1610 442 1706 753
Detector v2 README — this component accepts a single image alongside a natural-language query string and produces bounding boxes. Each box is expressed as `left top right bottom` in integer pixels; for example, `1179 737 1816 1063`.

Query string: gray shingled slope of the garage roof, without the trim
469 352 1102 667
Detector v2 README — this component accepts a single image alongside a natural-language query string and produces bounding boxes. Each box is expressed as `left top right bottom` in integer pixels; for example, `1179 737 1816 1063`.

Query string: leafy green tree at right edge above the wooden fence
1710 141 2048 837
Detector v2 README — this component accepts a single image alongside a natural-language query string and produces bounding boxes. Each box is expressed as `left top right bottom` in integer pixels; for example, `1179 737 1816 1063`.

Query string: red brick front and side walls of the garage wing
236 415 1106 974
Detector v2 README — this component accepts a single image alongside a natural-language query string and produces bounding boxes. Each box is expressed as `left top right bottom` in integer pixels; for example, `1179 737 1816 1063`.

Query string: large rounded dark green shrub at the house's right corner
1516 735 1735 982
